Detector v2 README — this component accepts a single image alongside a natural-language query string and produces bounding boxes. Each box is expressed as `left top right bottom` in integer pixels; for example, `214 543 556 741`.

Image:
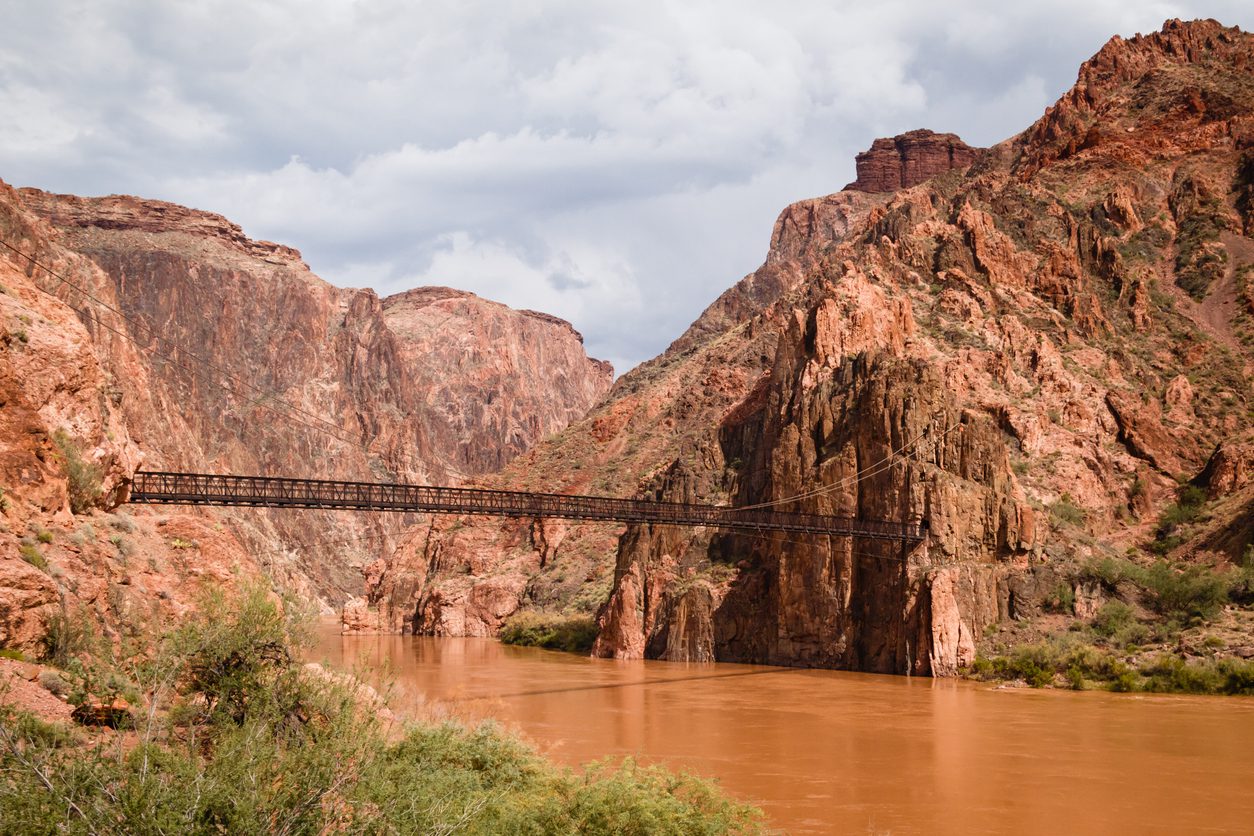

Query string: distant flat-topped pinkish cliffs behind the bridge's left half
11 189 612 603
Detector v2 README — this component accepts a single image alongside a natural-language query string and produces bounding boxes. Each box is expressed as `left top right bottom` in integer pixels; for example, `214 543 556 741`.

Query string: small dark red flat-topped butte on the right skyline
845 129 983 192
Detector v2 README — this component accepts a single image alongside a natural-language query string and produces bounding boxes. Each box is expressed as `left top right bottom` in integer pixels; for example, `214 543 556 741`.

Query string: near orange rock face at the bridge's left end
0 184 272 654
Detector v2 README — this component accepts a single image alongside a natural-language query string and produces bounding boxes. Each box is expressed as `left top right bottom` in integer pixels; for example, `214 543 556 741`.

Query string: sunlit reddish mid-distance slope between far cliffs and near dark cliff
367 186 884 636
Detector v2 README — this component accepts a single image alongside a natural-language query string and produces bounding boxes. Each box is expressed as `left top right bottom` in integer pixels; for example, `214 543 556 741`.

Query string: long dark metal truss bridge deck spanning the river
129 473 924 545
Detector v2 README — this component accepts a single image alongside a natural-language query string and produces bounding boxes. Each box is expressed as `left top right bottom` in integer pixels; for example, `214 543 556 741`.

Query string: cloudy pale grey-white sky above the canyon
0 0 1254 372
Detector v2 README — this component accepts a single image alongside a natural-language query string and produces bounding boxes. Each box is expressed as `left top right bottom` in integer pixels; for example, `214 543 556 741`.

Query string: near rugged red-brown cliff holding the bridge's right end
597 21 1254 674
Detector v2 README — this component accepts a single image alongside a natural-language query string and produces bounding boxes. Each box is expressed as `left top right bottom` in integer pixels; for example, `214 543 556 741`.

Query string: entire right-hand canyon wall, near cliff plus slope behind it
370 21 1254 674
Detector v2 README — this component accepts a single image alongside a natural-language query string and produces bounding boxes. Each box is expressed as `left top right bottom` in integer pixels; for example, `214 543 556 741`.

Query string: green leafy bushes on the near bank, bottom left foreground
0 589 760 835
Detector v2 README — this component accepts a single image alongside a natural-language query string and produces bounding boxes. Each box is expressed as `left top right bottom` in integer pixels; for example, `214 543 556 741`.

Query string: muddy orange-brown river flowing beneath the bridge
315 629 1254 833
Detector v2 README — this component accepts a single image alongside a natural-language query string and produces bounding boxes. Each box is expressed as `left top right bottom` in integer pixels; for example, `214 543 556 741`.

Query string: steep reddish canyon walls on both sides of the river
0 21 1254 676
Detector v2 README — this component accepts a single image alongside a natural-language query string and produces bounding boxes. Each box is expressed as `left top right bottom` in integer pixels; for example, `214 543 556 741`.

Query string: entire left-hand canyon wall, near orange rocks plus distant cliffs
0 185 612 647
